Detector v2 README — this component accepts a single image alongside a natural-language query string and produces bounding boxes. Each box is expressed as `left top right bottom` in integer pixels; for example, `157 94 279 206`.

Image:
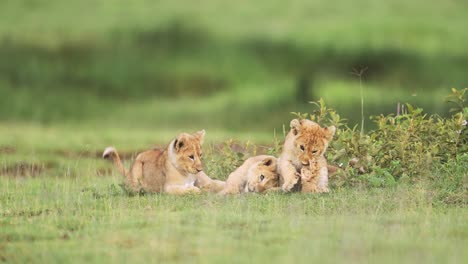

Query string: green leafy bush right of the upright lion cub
293 88 468 187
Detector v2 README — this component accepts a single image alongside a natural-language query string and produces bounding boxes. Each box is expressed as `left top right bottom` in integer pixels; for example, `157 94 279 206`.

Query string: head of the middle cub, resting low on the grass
245 157 279 193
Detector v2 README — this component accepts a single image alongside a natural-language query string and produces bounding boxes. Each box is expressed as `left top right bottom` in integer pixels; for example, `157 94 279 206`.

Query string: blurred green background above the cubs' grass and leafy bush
0 0 468 135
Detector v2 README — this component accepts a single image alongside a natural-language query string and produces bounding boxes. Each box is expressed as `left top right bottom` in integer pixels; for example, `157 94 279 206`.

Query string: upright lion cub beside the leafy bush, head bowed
278 119 336 192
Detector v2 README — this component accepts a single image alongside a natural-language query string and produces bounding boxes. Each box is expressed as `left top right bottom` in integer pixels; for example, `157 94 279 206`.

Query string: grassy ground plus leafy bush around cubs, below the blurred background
0 89 468 263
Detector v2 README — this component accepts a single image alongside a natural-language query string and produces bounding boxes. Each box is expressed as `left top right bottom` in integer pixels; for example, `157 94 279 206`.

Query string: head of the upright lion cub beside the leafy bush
291 119 336 166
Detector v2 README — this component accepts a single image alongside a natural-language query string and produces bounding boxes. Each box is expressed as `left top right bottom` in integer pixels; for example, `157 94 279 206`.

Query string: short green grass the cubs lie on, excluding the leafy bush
0 124 468 263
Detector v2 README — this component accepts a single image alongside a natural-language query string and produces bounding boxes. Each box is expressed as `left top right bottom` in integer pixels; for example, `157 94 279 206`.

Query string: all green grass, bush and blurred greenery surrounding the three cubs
0 0 468 263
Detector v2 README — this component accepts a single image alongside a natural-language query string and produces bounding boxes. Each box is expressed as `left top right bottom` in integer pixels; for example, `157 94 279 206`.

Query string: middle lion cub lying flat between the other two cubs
219 155 279 195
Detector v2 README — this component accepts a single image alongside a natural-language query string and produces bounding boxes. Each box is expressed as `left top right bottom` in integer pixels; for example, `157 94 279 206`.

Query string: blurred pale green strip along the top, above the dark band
0 0 468 54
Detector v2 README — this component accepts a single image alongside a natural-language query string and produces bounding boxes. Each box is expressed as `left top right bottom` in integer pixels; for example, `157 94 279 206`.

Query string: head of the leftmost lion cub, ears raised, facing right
169 130 205 174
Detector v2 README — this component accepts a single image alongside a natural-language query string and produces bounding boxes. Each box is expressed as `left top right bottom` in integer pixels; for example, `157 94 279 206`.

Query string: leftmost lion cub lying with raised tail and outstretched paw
103 130 224 194
